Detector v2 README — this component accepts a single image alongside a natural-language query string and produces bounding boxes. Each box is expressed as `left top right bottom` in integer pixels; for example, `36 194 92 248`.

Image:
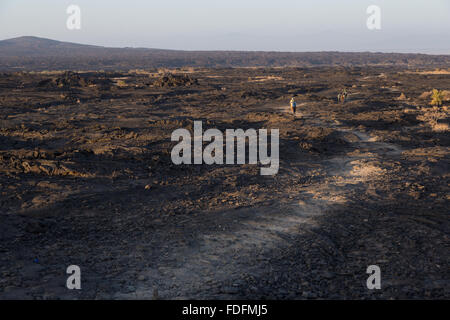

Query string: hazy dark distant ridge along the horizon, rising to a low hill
0 36 450 71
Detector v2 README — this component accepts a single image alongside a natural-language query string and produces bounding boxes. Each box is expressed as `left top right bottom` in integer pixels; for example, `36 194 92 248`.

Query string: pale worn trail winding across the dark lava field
124 101 401 299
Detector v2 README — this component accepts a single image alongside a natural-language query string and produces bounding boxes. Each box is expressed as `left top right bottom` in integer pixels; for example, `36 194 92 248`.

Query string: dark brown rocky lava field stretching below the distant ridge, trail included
0 67 450 299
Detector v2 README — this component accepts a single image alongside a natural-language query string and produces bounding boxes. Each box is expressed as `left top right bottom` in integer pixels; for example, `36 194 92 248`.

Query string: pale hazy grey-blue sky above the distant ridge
0 0 450 54
